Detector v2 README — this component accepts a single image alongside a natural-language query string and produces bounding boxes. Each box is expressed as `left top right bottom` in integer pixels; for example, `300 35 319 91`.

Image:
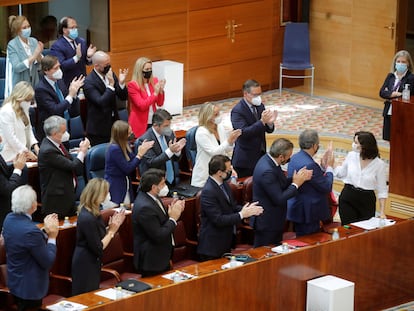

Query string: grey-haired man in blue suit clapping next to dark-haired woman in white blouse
287 130 335 236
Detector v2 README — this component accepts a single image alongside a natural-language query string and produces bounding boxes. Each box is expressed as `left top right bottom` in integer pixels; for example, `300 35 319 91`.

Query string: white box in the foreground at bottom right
306 275 355 311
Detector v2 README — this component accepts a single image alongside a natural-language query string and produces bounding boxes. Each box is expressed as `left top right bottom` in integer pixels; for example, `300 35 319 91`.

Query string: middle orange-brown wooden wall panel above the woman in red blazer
110 13 187 52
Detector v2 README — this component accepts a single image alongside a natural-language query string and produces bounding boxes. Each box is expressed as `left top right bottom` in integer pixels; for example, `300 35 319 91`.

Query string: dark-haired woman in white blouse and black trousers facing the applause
335 131 388 225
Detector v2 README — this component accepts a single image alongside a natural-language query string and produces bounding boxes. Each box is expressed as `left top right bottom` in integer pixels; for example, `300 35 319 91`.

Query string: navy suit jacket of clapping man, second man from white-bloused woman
250 154 298 235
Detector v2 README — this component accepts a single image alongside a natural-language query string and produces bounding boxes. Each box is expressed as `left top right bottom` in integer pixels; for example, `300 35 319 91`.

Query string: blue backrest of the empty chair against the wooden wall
282 23 310 66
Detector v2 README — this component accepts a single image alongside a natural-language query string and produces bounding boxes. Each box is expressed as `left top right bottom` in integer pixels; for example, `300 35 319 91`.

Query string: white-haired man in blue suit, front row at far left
3 185 59 310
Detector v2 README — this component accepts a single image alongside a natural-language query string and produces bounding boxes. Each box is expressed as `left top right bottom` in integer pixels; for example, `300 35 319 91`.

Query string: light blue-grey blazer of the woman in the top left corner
7 36 40 88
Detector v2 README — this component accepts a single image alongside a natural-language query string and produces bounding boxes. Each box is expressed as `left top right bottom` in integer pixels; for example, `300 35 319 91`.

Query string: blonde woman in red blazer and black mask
128 57 165 137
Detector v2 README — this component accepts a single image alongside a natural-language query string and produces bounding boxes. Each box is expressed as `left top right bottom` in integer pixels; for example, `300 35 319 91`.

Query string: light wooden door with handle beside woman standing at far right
349 0 398 98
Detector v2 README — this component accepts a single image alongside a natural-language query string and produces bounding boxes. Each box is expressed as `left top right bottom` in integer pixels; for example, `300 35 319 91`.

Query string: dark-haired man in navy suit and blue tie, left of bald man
35 55 85 141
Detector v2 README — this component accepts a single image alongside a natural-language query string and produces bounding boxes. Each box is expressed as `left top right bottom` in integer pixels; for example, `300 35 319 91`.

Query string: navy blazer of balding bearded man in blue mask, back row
50 36 91 87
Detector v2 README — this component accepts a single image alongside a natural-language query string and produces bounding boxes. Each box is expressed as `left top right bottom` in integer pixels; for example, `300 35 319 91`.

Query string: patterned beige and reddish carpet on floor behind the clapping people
173 90 389 147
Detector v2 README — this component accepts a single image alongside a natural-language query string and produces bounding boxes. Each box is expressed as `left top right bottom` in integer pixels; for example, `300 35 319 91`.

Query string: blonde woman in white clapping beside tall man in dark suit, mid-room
191 103 241 187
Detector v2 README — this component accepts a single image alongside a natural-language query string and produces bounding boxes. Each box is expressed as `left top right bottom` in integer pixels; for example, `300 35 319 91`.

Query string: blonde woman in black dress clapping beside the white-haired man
72 178 125 295
